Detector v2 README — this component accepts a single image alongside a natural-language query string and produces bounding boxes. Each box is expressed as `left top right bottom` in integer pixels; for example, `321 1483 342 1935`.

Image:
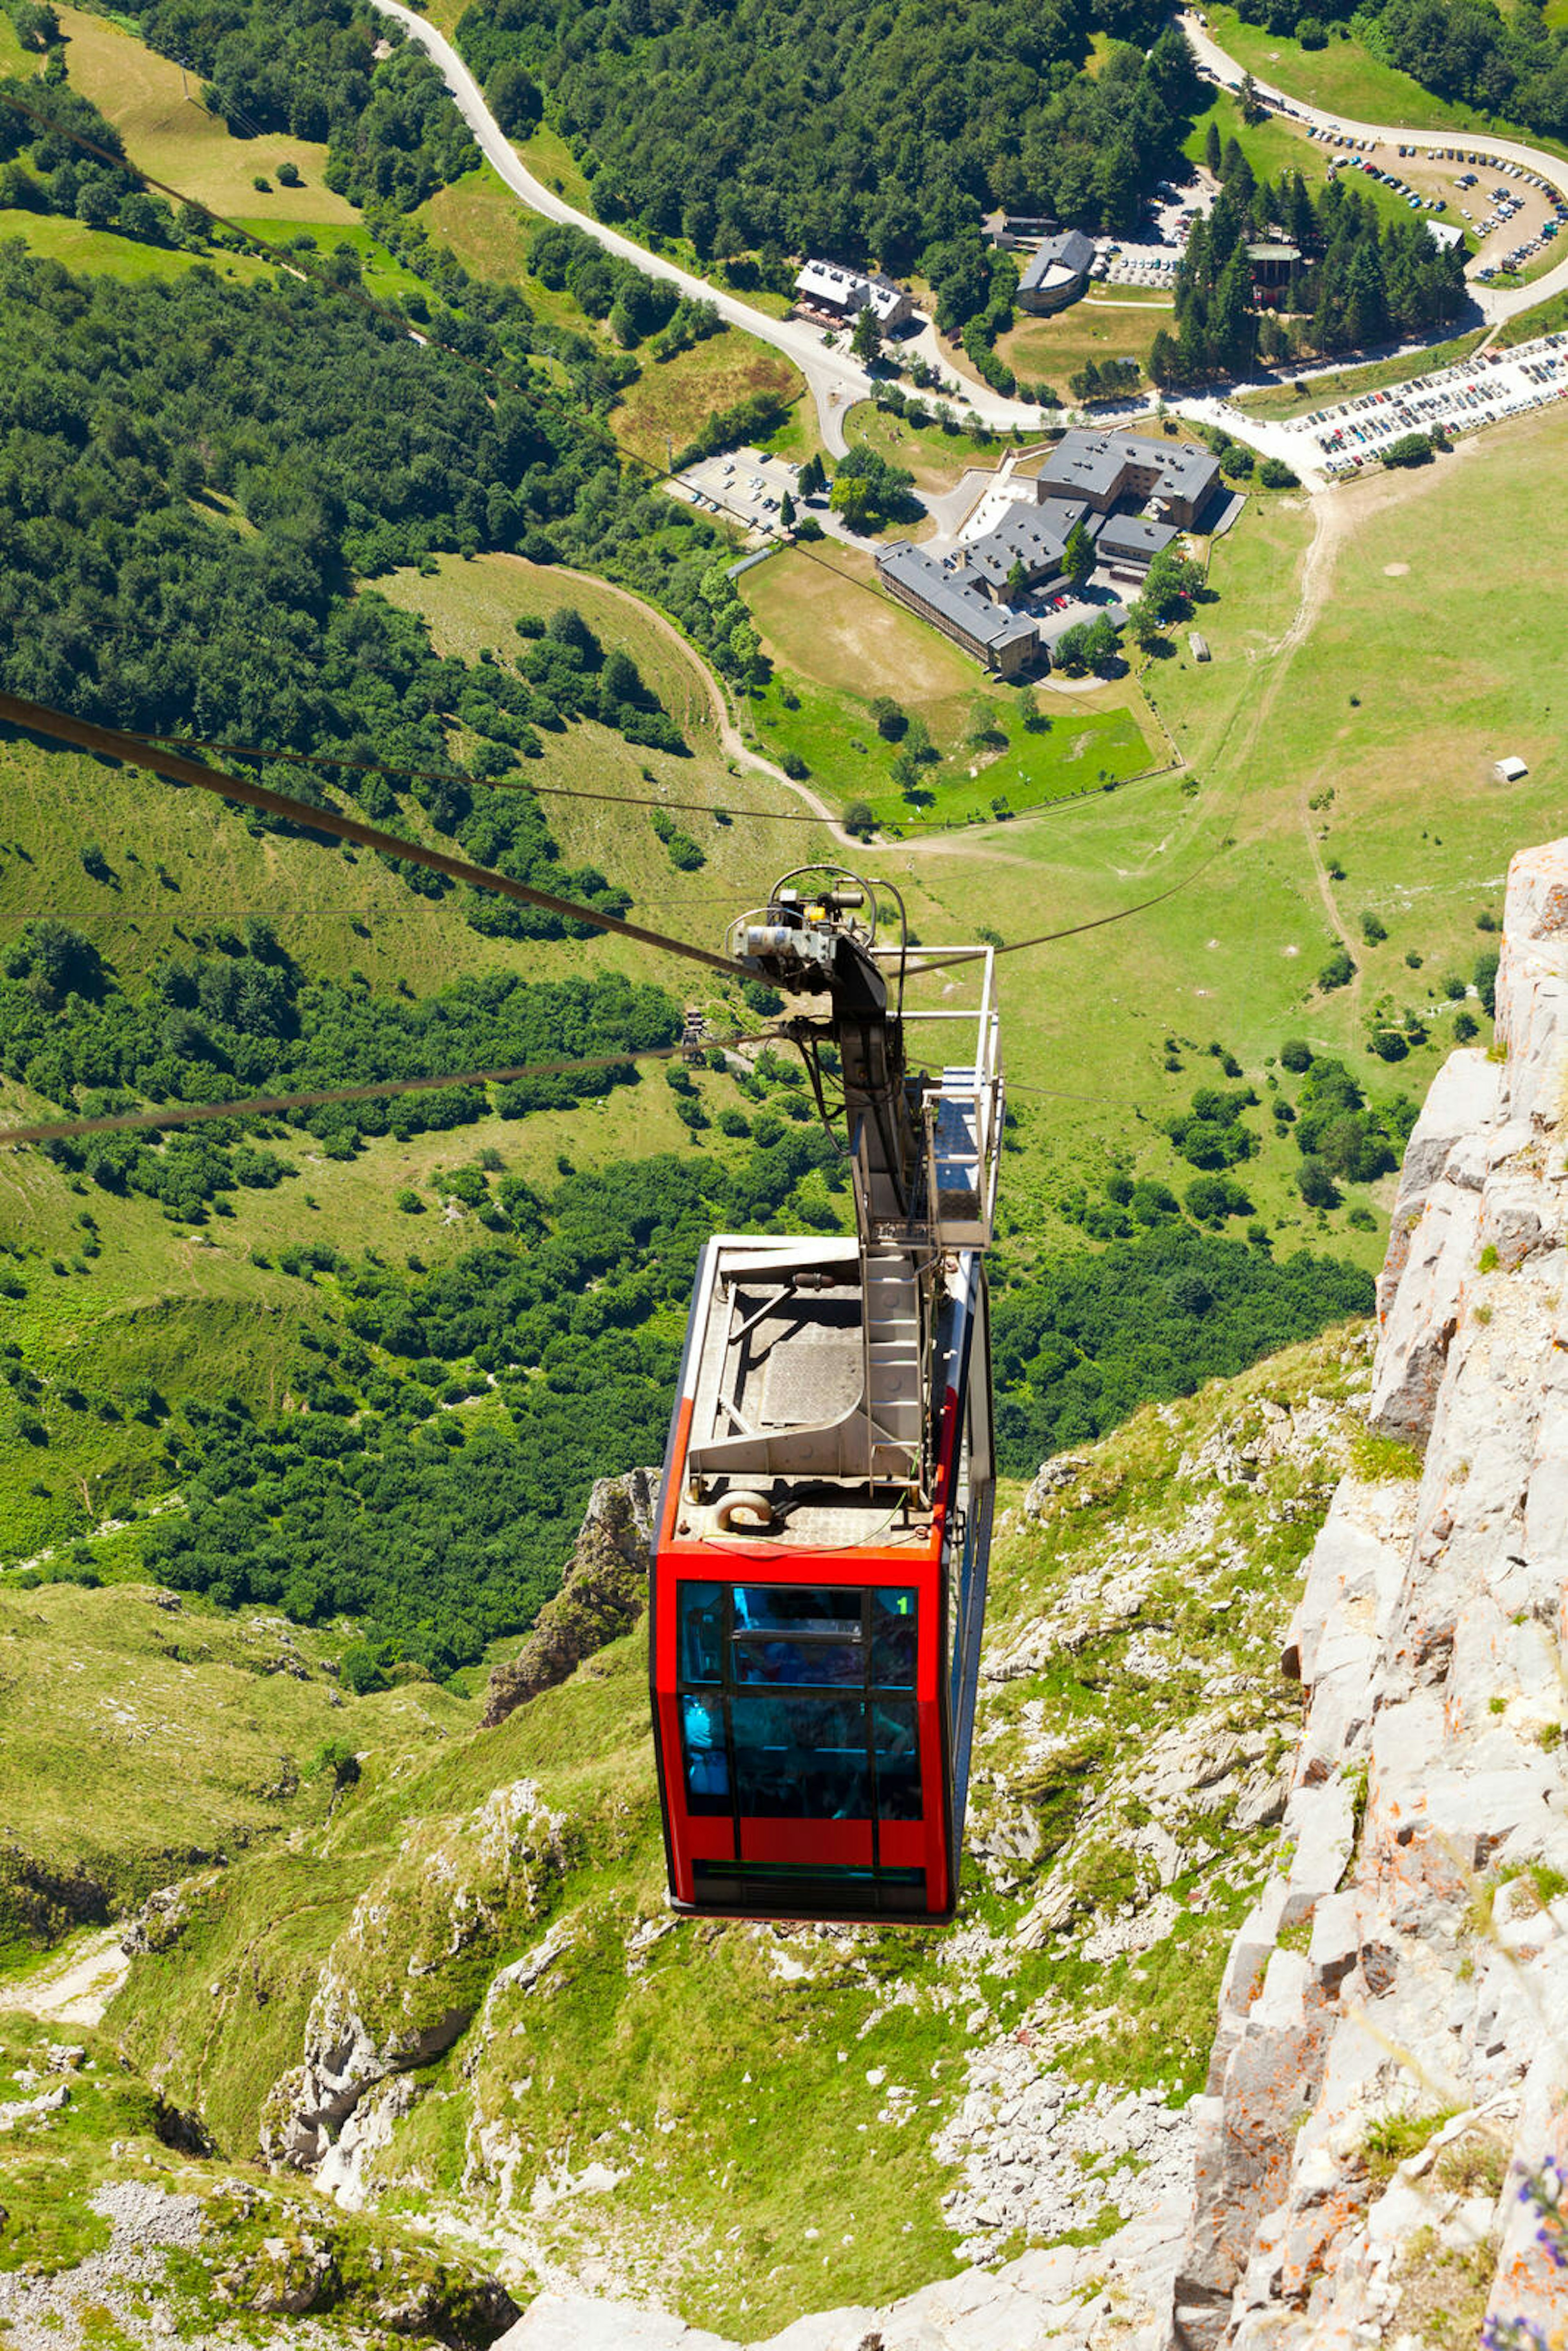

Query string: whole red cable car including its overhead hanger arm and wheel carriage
649 877 1002 1923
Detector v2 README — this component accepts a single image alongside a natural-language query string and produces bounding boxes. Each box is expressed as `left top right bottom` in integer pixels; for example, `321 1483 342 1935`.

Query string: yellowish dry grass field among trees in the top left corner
56 7 357 228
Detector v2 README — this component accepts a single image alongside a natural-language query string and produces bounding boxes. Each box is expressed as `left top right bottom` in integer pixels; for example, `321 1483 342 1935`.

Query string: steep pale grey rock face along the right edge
1171 842 1568 2351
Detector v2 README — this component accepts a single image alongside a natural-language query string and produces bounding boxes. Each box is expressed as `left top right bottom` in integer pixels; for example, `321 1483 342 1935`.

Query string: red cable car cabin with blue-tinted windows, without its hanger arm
651 1239 992 1923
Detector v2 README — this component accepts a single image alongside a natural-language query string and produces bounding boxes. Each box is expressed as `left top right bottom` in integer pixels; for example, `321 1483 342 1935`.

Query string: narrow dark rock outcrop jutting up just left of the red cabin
482 1469 658 1730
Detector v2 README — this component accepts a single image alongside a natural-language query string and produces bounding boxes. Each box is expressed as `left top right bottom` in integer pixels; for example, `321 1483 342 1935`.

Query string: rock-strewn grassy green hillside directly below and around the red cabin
92 1338 1363 2337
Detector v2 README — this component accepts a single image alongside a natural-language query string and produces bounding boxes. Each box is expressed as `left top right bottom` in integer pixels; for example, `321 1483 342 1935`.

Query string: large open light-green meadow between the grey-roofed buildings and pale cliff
790 414 1568 1267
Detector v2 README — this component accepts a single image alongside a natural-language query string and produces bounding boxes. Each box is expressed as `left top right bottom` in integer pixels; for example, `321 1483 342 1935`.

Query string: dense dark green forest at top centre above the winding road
456 0 1194 317
